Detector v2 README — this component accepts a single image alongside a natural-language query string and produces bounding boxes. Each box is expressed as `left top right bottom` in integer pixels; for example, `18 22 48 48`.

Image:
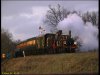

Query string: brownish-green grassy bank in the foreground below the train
1 52 99 74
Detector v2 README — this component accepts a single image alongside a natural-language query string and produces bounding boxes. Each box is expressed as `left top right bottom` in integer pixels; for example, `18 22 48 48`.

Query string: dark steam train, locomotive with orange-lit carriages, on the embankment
16 30 77 56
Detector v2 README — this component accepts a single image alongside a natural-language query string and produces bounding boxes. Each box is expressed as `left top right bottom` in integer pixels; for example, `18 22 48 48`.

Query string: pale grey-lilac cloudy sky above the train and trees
1 0 98 41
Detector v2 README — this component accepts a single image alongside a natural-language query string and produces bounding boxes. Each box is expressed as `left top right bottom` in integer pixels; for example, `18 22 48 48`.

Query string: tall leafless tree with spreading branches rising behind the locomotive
44 4 70 32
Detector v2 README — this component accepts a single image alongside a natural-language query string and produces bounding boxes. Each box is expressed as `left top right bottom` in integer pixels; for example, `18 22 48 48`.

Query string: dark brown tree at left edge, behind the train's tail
1 28 16 53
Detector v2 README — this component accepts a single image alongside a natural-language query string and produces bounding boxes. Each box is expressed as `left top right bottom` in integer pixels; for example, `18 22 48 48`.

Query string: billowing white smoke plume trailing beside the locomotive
57 14 98 50
